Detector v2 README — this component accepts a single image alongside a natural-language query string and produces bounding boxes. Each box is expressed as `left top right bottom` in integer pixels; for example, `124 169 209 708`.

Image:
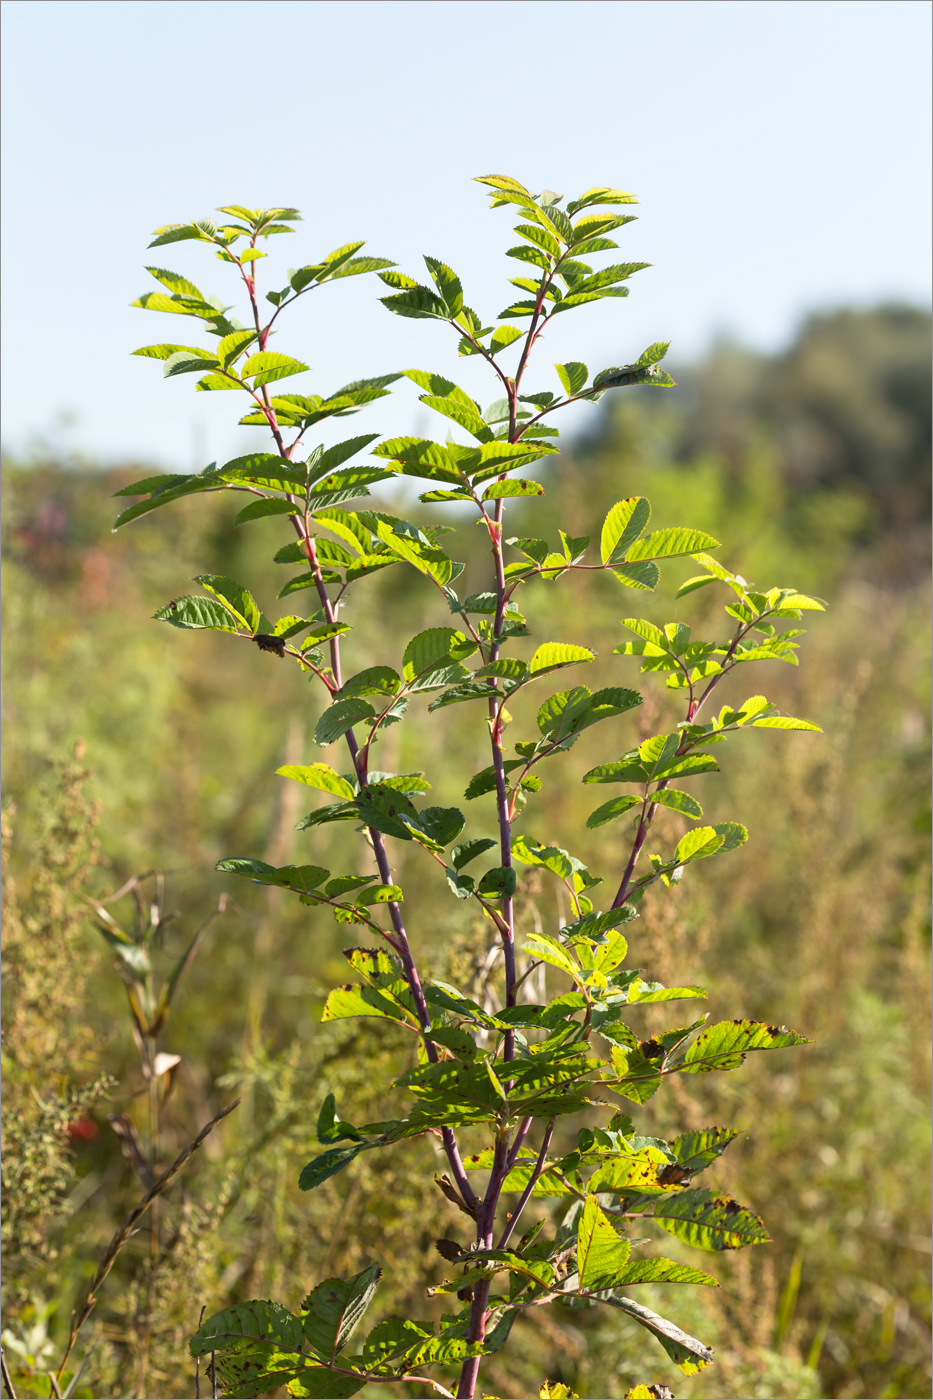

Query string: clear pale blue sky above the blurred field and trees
3 0 930 470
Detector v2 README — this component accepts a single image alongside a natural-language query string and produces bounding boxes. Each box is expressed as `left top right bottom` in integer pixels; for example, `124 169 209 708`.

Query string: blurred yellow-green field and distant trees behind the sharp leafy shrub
3 307 930 1400
